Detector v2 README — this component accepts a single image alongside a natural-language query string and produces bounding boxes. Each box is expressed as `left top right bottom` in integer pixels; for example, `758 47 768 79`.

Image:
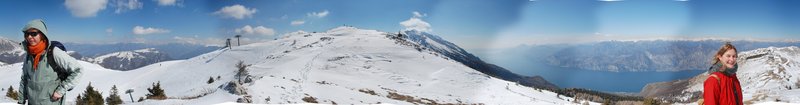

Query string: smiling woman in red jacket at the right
703 42 742 105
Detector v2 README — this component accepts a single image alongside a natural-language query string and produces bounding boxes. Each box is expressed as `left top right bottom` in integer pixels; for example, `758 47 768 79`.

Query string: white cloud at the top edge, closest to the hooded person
64 0 108 18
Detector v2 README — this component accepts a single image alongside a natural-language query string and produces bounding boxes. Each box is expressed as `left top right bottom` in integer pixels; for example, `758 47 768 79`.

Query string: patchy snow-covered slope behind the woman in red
642 46 800 103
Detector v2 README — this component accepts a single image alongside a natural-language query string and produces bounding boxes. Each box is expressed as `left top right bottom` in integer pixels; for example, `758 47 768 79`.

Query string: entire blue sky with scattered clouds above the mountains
0 0 800 49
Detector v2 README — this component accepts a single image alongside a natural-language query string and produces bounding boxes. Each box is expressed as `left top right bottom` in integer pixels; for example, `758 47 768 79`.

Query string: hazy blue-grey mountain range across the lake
491 39 800 72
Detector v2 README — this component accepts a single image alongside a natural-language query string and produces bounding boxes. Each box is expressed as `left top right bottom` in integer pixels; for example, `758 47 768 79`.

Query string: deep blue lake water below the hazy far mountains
508 61 705 93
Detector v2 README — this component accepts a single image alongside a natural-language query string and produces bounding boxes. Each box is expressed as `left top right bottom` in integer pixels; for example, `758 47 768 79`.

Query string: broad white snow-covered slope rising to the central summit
0 27 597 105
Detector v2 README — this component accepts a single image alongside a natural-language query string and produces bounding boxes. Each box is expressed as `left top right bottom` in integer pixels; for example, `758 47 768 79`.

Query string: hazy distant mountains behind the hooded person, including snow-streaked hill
0 38 220 70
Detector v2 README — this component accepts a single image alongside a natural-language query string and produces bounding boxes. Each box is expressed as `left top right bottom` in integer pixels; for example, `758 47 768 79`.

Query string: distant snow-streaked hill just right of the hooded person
85 48 172 70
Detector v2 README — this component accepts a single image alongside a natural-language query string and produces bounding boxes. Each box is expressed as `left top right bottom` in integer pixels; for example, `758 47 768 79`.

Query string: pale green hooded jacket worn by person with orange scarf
18 19 82 105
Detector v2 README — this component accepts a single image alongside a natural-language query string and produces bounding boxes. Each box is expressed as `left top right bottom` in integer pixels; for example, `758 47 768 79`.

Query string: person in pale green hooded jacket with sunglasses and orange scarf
18 19 82 105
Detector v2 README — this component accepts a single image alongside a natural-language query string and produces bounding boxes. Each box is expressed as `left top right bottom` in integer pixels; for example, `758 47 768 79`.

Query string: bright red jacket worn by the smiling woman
703 72 742 105
